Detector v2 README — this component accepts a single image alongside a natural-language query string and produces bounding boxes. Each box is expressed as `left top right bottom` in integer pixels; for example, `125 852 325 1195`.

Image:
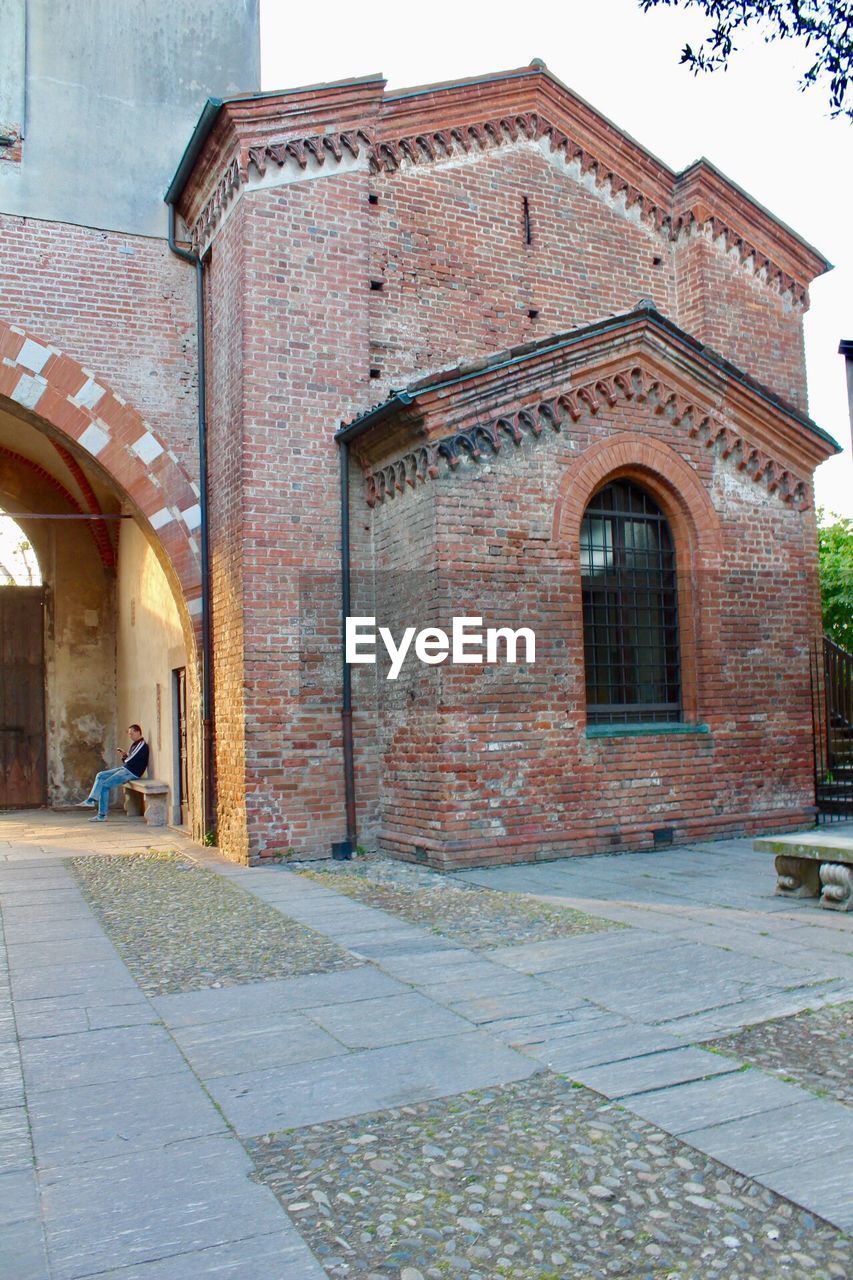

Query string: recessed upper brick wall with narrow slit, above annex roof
369 143 678 388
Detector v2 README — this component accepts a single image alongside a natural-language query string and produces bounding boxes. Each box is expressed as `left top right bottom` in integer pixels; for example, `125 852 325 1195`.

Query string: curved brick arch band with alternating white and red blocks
0 320 201 645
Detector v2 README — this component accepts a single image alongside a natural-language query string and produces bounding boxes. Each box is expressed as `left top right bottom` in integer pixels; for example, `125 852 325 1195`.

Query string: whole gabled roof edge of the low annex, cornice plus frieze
338 306 840 509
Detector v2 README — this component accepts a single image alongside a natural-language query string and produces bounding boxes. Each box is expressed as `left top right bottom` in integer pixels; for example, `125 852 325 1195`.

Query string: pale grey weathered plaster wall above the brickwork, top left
0 0 260 236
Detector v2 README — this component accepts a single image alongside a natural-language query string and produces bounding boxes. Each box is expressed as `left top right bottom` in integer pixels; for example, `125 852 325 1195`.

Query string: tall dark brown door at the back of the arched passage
0 586 46 809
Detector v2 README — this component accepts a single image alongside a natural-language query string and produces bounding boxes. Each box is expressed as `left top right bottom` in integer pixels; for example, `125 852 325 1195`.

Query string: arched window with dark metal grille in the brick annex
580 480 681 724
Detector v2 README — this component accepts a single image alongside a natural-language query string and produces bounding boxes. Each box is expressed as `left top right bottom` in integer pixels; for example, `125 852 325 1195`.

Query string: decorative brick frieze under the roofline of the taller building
180 69 826 310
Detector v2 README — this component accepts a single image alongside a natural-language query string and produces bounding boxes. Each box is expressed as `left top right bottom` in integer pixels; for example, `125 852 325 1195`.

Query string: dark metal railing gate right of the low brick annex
811 637 853 822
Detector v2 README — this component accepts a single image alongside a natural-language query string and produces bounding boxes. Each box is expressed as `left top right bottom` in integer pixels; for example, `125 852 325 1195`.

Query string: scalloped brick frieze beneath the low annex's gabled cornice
365 365 811 511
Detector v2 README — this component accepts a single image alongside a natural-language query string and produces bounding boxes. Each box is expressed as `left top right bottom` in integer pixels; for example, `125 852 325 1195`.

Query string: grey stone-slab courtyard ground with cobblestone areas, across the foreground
0 815 853 1280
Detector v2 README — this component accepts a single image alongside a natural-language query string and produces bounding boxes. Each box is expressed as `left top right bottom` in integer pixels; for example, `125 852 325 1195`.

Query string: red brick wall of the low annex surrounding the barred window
356 389 816 865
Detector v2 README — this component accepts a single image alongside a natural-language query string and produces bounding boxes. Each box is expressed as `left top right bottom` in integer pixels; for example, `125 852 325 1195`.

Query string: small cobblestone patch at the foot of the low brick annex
296 855 619 950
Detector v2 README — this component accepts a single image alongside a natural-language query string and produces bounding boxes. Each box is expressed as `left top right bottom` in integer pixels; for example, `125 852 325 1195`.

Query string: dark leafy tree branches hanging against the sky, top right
639 0 853 119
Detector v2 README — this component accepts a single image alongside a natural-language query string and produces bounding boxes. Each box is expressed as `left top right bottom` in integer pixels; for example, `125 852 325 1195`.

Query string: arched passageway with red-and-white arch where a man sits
0 323 201 835
